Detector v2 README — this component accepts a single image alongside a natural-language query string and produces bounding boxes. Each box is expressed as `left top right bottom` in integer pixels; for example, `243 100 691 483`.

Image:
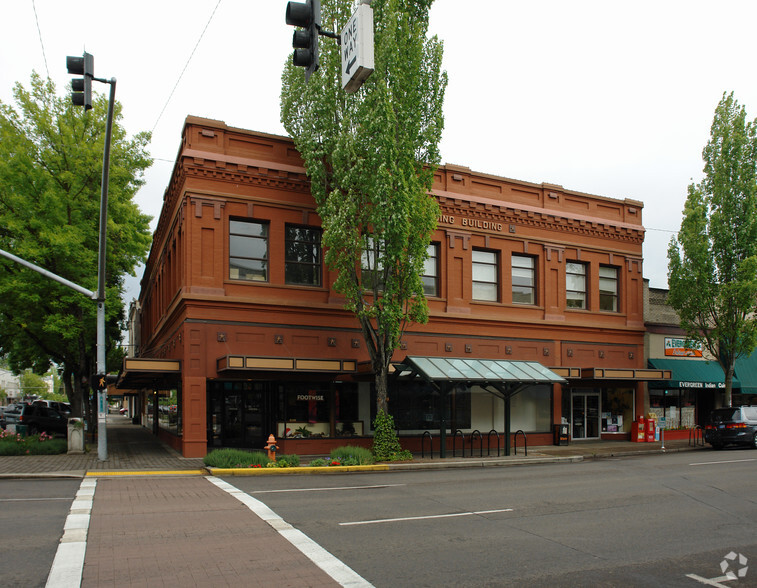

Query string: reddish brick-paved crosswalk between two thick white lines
81 476 348 588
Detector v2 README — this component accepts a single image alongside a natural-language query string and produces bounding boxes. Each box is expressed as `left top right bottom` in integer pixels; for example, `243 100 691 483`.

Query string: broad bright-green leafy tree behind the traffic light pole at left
0 73 152 415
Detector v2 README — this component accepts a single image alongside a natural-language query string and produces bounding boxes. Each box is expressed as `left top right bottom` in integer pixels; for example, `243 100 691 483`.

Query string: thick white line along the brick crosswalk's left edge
46 478 97 588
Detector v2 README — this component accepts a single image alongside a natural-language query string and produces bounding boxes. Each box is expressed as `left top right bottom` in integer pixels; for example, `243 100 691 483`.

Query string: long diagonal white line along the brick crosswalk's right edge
206 476 373 588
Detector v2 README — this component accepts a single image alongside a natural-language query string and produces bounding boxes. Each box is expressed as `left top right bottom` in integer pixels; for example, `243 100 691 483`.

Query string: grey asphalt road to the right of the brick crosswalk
227 450 757 587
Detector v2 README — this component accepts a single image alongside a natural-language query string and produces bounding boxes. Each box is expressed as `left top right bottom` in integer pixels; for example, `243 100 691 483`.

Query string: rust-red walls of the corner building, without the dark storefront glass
138 117 646 456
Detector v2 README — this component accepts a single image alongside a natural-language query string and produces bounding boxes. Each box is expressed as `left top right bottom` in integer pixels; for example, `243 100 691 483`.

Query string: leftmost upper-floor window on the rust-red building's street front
229 220 268 282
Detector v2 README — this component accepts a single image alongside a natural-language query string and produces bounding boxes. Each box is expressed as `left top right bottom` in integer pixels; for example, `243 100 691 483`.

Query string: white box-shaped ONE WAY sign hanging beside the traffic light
341 4 374 94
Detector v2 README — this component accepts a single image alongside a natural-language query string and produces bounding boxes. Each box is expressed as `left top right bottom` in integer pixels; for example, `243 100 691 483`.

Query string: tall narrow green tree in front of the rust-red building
281 0 447 412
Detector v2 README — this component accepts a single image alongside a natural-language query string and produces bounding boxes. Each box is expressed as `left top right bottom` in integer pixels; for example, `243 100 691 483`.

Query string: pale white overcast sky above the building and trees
0 0 757 298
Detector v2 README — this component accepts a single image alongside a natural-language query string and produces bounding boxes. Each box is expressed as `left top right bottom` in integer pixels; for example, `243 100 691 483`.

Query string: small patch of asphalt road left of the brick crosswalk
0 479 81 588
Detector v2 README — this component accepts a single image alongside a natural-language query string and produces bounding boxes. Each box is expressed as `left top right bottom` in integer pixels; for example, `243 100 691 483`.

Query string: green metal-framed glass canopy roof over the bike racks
393 356 567 386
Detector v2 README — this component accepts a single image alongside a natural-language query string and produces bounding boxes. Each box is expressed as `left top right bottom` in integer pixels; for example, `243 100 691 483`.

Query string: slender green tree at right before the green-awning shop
668 93 757 406
